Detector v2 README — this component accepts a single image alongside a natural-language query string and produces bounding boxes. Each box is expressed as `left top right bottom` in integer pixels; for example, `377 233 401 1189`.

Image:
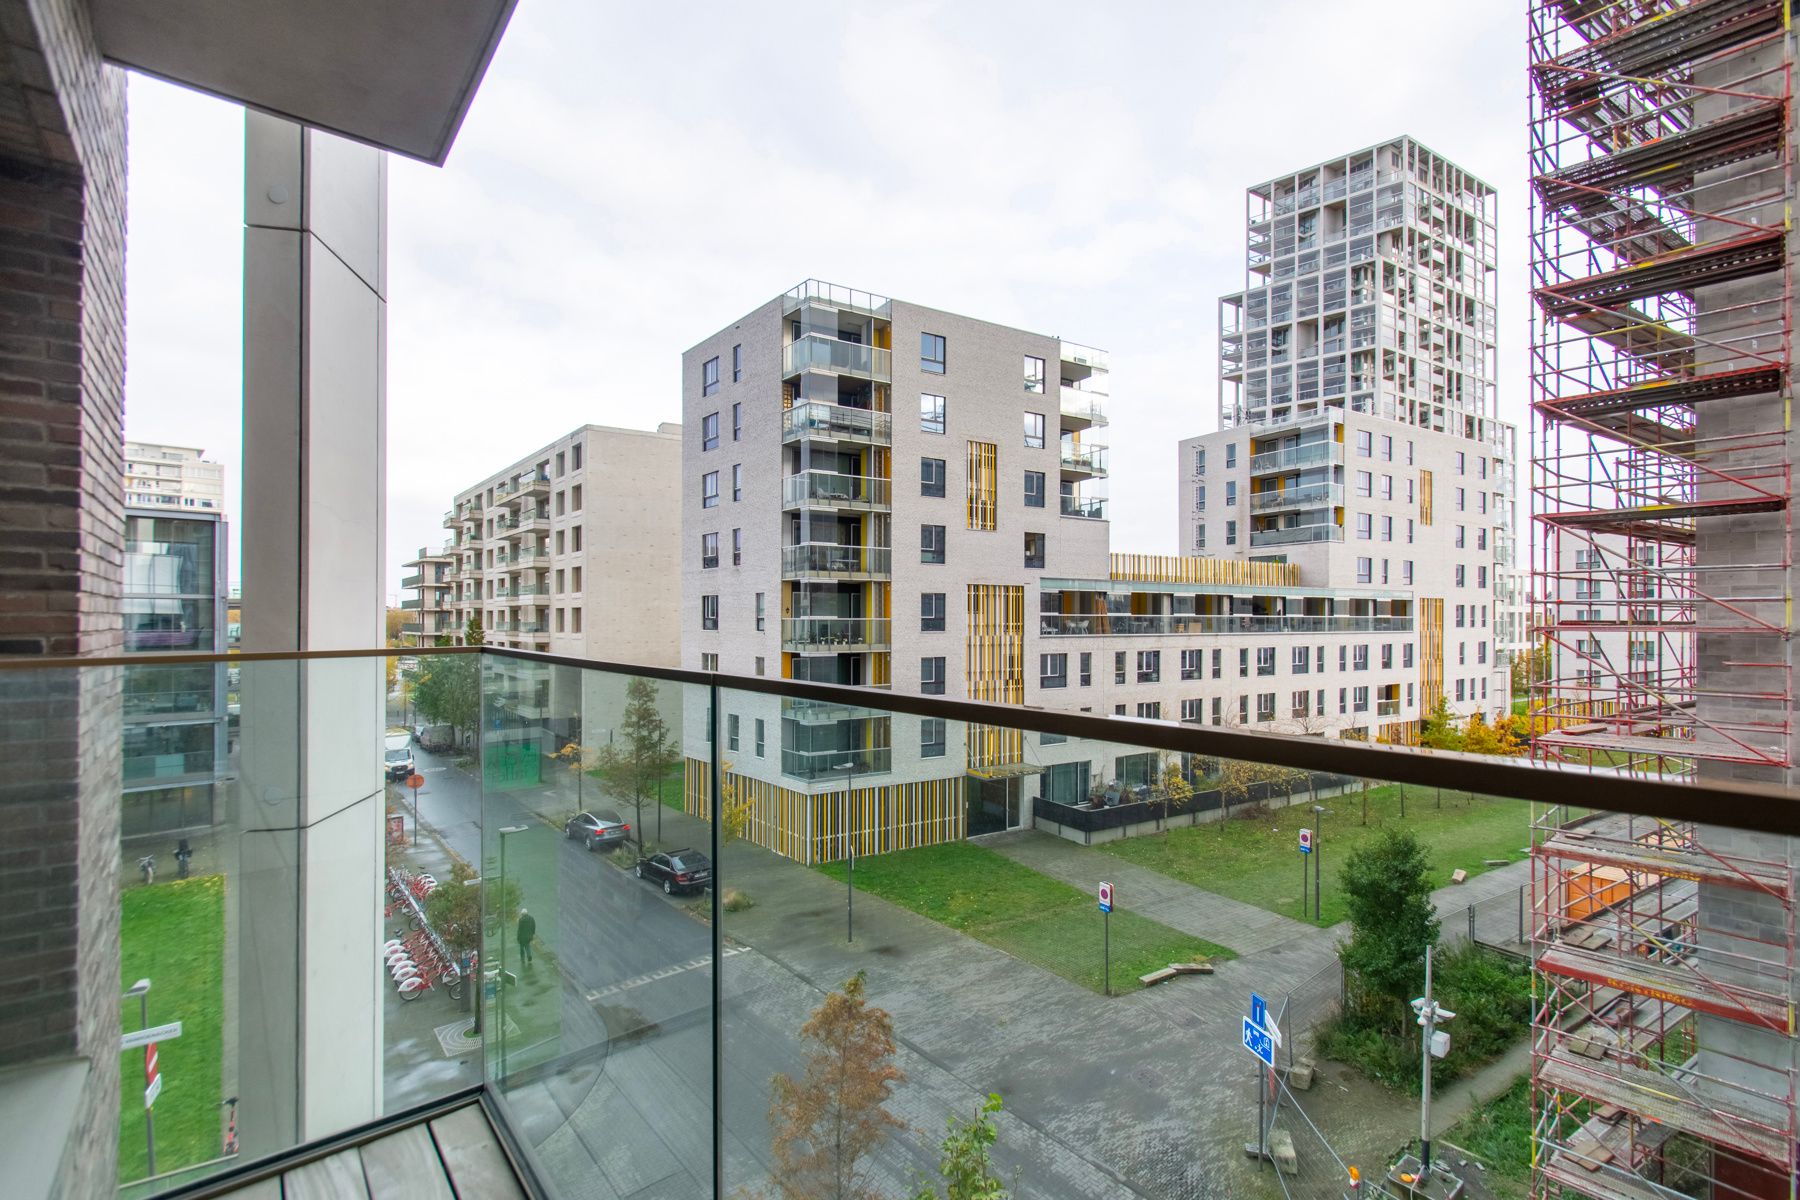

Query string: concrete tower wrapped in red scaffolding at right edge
1528 0 1796 1200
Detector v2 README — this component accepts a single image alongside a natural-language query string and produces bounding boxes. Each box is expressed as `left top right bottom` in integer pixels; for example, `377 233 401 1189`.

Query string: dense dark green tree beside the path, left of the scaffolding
1337 826 1438 1027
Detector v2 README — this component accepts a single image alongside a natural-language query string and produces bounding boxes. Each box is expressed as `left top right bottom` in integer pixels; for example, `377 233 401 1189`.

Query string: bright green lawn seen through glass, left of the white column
119 874 225 1180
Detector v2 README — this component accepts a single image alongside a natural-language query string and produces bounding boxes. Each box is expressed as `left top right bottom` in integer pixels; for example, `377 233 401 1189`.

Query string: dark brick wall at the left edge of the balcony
0 0 126 1196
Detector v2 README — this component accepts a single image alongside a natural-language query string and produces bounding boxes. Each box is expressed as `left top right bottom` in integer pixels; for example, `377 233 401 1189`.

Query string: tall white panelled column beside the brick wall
236 112 387 1151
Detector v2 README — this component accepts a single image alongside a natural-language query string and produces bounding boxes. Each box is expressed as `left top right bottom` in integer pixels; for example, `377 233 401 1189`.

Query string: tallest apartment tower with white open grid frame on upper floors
1179 137 1517 716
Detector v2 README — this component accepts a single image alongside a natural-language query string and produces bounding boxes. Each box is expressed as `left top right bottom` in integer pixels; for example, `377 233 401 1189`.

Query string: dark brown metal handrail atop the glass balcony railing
10 646 1800 837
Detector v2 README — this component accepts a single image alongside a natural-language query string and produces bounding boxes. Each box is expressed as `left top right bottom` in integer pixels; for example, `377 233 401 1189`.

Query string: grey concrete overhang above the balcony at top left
88 0 517 166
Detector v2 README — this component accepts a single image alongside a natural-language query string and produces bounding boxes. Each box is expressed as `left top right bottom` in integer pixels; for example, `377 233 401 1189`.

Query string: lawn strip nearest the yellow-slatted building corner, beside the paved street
819 842 1237 991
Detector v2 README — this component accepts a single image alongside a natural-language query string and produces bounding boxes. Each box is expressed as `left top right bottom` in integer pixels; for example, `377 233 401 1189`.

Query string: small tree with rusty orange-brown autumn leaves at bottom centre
769 972 905 1200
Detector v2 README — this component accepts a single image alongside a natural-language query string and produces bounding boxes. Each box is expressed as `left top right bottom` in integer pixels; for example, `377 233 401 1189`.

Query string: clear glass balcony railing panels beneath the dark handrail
14 648 1800 1200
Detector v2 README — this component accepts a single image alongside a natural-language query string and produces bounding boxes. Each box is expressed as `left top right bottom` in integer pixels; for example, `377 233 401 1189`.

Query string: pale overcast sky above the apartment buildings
126 0 1526 592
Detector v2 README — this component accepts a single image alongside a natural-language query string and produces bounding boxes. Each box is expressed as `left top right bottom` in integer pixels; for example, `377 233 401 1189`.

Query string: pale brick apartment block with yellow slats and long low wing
680 281 1440 860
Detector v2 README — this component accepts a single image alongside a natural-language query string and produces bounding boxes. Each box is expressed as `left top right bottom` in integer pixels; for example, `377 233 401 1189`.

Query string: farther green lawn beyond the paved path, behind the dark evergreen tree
1098 784 1532 925
